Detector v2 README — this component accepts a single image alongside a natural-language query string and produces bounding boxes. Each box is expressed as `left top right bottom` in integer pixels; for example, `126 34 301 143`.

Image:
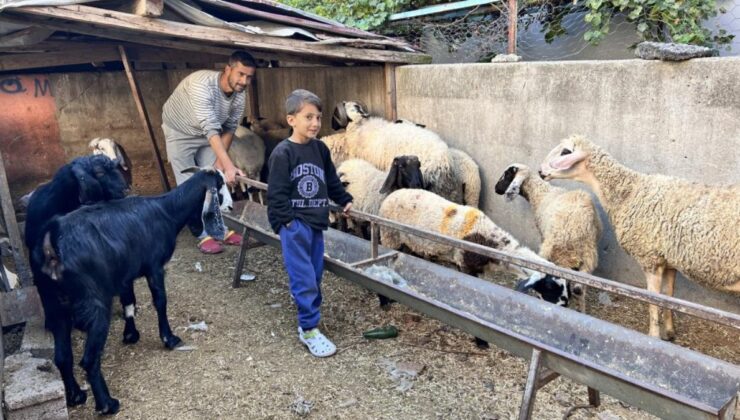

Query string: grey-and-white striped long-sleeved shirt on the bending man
162 70 246 139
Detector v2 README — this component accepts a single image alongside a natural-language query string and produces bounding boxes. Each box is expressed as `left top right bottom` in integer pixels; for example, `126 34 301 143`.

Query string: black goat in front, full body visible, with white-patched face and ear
31 170 231 414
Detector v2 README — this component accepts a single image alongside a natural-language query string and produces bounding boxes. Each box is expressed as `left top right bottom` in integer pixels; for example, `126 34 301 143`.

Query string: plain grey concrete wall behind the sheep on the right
397 57 740 312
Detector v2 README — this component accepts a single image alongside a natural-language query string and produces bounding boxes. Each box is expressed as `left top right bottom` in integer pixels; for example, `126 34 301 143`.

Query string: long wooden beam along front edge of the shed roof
5 5 431 63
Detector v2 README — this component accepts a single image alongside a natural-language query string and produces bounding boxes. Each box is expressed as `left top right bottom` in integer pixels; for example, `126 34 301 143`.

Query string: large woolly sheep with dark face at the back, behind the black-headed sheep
322 102 462 202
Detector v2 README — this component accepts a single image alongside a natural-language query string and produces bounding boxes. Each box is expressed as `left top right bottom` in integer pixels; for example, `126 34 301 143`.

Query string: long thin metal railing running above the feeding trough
237 177 740 330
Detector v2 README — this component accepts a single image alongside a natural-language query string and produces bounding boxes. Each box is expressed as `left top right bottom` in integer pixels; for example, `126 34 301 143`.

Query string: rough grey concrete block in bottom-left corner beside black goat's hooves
3 352 68 420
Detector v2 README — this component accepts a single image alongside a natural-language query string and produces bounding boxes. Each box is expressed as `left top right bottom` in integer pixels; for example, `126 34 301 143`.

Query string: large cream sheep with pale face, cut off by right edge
540 135 740 340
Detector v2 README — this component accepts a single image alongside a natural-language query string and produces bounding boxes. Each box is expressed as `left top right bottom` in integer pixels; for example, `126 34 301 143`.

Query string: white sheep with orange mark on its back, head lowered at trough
379 189 569 305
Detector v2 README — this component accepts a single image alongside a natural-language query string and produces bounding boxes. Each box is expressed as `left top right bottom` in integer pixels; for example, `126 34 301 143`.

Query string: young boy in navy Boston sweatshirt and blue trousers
267 89 352 357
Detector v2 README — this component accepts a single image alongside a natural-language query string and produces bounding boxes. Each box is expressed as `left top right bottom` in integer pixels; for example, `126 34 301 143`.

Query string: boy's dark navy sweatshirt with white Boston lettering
267 139 352 232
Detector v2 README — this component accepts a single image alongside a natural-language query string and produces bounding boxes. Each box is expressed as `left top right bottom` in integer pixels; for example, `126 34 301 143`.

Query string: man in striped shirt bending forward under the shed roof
162 51 257 254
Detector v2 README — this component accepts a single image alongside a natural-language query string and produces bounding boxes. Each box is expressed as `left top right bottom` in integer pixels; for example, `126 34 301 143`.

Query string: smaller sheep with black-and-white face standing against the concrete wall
495 163 602 312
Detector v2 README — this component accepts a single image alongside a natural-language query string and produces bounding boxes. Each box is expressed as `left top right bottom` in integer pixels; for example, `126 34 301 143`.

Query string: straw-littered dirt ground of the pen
52 232 740 420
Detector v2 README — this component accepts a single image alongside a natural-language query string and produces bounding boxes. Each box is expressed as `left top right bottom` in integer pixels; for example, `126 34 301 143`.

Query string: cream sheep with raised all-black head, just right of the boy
337 156 424 239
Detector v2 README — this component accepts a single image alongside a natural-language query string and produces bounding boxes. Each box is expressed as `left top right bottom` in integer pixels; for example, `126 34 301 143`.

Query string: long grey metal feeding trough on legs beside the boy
226 201 740 419
